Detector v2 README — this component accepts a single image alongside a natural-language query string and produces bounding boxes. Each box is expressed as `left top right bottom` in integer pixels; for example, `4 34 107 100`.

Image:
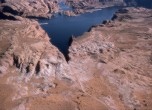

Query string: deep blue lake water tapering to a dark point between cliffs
39 7 120 55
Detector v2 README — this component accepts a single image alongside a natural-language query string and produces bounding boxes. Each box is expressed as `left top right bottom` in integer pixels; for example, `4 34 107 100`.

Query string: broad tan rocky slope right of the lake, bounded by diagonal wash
69 8 152 110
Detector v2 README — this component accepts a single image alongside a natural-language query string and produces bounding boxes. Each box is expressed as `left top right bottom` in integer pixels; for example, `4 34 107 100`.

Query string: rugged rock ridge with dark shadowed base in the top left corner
0 0 59 18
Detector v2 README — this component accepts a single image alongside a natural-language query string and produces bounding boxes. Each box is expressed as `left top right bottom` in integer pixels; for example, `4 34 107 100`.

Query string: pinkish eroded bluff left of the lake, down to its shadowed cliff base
0 19 72 77
